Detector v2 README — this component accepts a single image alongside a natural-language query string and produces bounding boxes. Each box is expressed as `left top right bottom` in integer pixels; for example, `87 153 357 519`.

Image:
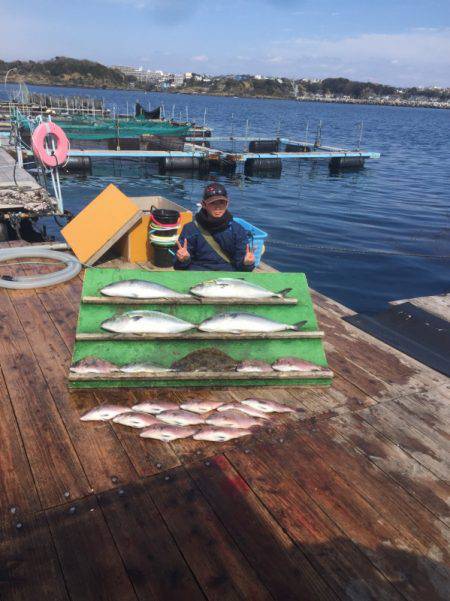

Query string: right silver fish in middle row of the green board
198 313 306 334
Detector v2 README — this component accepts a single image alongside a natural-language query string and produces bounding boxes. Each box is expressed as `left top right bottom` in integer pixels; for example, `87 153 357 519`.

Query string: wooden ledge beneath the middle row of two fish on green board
76 331 324 340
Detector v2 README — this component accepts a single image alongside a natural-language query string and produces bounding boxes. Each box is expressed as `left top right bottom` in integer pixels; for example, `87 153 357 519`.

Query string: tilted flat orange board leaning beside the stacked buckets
61 184 142 265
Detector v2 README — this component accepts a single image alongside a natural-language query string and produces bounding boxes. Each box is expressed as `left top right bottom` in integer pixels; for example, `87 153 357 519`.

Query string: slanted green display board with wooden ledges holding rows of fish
69 268 331 388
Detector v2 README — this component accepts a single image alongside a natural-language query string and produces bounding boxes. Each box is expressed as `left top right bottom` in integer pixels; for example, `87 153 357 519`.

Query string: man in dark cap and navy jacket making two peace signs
174 184 255 271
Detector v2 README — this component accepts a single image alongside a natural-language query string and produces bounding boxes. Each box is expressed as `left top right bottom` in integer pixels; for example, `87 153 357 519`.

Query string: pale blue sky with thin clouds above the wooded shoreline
0 0 450 87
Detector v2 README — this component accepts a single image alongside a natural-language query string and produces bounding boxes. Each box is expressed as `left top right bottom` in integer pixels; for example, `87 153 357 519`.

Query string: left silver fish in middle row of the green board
101 310 196 334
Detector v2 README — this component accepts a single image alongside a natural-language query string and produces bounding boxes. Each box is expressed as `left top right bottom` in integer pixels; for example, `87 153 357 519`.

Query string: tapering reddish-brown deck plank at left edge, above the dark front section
0 371 41 515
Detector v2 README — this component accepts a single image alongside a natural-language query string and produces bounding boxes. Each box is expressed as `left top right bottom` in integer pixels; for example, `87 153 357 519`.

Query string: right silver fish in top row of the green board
190 278 292 299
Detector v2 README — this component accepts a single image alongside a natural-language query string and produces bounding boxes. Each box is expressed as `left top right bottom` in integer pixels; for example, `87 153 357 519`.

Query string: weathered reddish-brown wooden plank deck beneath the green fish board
0 241 450 601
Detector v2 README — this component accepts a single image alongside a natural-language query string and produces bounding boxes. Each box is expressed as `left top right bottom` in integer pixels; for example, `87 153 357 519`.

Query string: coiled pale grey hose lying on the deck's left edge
0 246 81 290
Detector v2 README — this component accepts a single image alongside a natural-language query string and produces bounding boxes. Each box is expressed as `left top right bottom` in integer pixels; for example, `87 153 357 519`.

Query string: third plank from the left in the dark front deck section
99 484 204 601
